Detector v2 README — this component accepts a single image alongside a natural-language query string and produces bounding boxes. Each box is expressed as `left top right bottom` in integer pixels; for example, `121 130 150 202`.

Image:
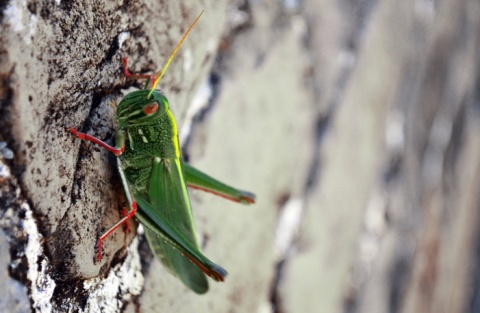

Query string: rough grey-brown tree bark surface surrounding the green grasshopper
0 0 480 313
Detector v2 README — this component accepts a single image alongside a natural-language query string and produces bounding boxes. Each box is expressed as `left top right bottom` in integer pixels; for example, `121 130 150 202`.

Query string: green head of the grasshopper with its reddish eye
117 89 168 125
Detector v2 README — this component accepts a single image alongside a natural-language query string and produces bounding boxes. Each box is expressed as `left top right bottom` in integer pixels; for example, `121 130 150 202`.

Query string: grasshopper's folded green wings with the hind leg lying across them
135 157 227 293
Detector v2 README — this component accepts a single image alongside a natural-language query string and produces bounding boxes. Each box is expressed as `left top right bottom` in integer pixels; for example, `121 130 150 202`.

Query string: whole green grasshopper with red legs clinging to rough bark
68 11 255 294
